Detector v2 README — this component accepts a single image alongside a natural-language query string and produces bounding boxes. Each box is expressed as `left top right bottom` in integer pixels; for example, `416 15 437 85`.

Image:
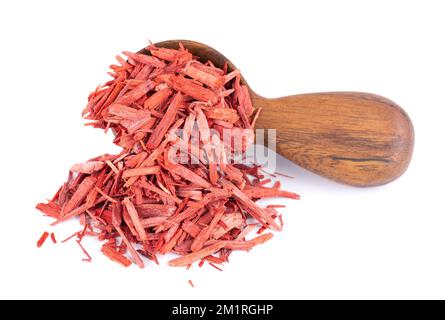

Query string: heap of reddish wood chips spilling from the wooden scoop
37 41 298 268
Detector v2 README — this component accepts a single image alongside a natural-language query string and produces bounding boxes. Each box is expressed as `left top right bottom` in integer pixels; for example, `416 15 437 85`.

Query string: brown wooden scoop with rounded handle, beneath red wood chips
146 40 414 187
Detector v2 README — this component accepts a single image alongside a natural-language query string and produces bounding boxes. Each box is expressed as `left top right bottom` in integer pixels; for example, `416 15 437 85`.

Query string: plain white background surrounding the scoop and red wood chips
0 0 445 299
